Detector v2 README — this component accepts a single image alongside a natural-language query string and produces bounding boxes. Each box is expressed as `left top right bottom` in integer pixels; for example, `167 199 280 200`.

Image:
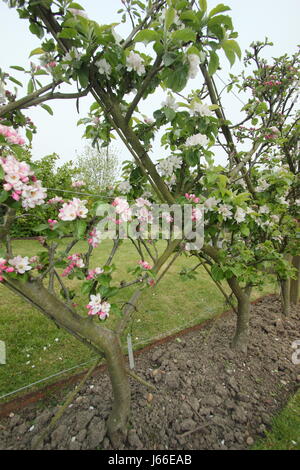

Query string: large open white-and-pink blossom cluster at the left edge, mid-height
0 155 47 209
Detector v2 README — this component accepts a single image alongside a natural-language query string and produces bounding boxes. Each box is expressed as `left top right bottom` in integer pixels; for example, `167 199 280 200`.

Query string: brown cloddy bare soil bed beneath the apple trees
0 296 300 450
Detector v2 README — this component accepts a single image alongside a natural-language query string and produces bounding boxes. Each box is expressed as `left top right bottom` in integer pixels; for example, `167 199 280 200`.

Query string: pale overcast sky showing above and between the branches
0 0 300 170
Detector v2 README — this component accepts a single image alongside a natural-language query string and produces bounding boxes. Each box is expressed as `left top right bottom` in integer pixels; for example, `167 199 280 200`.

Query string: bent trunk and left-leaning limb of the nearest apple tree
4 279 130 448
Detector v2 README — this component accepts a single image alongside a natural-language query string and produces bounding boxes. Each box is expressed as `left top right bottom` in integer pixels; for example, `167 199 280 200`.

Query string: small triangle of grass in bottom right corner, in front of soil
252 390 300 450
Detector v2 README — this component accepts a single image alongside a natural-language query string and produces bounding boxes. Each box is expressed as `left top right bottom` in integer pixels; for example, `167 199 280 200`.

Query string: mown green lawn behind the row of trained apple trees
0 240 274 402
